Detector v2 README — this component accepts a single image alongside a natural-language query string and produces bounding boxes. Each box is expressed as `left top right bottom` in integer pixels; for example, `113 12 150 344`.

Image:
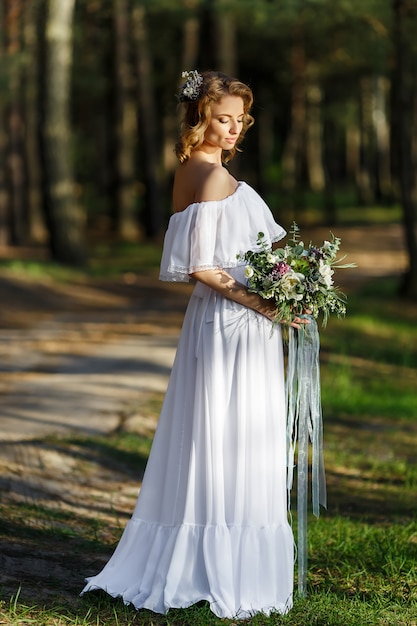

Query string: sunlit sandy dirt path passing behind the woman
0 225 406 432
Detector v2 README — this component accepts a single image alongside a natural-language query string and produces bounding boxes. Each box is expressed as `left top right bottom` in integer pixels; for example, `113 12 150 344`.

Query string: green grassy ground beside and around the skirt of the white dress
0 266 417 626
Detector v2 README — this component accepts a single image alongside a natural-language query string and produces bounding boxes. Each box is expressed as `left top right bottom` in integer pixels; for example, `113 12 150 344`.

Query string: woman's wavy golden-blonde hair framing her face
174 72 255 163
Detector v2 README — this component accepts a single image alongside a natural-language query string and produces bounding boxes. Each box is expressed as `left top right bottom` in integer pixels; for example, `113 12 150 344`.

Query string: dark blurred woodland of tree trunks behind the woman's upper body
0 0 417 296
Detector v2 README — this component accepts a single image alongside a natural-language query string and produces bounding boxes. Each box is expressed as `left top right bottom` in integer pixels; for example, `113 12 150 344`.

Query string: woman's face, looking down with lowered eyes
203 95 245 150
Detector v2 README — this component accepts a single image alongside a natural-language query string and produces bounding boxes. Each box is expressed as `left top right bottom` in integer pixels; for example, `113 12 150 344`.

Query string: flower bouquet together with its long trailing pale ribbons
240 223 355 597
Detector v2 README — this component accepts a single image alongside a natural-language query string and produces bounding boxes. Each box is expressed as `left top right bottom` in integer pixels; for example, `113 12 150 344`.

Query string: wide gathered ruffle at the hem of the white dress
83 518 292 619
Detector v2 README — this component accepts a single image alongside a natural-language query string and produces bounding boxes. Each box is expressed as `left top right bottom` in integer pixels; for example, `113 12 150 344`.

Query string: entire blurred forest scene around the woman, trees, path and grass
0 0 417 626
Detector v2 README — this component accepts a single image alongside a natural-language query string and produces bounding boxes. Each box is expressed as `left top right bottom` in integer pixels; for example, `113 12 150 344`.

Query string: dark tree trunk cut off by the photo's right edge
392 0 417 299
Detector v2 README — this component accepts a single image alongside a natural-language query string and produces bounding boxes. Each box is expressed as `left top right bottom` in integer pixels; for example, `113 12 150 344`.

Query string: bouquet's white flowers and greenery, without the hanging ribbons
240 222 355 326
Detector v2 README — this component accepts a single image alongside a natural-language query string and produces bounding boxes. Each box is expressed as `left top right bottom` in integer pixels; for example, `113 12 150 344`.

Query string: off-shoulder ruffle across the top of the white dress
159 182 285 282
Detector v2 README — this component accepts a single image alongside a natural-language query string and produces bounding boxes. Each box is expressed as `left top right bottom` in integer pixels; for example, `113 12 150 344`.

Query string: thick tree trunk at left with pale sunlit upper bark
44 0 86 265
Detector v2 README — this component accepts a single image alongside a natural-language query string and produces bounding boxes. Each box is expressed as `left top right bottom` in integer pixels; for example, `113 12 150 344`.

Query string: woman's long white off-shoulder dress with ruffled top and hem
82 182 294 619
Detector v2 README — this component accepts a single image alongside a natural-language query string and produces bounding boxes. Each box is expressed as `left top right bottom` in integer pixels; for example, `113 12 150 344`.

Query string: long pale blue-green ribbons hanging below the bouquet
285 315 327 597
